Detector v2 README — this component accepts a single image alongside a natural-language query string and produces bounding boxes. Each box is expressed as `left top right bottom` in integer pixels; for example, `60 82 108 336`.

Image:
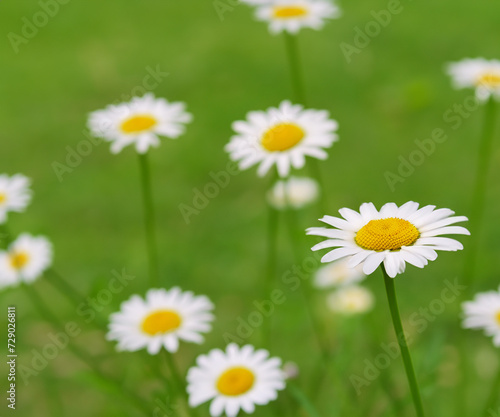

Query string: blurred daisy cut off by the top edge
255 0 341 34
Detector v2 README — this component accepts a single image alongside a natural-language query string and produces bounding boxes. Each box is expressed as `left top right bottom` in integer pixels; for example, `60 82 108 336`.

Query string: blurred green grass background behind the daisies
0 0 500 417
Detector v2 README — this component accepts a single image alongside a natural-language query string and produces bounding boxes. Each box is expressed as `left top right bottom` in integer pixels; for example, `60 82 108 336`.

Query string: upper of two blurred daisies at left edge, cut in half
0 174 31 224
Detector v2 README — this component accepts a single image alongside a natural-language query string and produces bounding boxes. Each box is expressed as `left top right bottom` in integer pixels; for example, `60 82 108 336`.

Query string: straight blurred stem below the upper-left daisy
139 154 160 287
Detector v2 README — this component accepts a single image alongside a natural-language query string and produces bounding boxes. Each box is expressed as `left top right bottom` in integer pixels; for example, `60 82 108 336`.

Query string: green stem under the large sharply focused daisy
381 266 424 417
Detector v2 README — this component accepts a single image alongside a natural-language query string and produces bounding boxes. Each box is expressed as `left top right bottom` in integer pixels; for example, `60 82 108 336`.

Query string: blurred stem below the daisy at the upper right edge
464 96 496 285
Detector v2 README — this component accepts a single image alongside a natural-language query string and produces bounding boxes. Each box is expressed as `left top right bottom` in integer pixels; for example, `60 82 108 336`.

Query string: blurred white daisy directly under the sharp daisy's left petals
314 258 366 288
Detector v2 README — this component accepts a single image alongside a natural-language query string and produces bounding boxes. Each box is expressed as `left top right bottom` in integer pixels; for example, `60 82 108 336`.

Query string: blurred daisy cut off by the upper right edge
447 58 500 101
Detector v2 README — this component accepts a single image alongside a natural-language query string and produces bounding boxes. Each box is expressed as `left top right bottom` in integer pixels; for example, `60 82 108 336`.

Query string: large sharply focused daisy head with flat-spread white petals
307 201 470 278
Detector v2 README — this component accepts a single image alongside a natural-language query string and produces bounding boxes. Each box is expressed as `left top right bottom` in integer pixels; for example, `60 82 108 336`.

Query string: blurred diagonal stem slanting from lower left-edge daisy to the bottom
24 285 151 416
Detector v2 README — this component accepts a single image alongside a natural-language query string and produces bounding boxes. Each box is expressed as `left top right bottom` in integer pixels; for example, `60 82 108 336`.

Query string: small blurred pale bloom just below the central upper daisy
267 177 319 210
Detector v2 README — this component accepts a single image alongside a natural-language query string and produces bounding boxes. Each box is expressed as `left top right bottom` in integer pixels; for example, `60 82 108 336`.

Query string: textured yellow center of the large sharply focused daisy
355 217 420 252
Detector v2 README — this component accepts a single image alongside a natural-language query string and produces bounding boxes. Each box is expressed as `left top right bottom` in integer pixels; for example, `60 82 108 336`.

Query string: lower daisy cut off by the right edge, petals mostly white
463 288 500 347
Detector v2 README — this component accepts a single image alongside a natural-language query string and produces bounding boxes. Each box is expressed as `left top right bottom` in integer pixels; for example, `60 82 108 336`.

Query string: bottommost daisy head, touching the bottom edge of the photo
187 343 285 417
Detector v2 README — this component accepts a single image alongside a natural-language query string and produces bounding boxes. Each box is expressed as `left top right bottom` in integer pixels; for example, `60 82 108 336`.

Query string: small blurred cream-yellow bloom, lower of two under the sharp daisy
327 285 375 314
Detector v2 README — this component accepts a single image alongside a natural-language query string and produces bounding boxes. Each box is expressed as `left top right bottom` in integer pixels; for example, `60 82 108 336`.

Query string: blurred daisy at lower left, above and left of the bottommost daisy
107 287 214 355
